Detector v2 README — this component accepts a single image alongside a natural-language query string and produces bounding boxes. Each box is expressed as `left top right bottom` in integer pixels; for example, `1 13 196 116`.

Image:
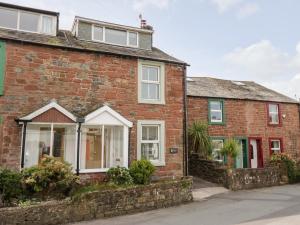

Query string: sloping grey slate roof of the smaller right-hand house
187 77 299 103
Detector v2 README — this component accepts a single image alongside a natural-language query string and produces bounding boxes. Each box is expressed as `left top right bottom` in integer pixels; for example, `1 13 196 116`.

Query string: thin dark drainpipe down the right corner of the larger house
183 65 189 176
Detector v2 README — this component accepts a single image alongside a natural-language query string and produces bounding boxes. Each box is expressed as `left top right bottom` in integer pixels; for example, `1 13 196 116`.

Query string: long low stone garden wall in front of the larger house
0 177 193 225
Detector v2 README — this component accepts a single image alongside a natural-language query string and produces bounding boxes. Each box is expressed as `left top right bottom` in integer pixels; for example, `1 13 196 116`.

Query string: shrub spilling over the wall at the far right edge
270 153 299 183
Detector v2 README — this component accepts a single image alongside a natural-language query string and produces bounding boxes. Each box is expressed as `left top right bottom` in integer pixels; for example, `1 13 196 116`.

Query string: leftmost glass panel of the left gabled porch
24 124 51 167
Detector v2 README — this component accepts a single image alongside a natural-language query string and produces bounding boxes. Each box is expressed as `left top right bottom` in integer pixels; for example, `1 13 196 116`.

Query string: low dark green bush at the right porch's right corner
107 166 133 185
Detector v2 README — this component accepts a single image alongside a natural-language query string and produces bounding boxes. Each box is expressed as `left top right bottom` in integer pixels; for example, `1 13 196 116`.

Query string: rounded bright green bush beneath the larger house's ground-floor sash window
129 159 155 184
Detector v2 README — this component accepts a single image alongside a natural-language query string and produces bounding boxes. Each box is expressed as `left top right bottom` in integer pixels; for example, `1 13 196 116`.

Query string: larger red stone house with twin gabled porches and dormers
0 3 186 177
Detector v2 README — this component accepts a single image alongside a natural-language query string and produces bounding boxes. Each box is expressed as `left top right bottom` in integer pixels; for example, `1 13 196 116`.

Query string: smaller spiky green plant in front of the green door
220 138 239 169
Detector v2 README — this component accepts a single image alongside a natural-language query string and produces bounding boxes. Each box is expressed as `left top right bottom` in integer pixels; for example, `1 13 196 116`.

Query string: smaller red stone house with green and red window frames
187 77 300 168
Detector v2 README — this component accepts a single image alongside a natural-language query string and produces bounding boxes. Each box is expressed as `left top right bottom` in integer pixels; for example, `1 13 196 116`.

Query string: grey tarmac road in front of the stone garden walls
72 184 300 225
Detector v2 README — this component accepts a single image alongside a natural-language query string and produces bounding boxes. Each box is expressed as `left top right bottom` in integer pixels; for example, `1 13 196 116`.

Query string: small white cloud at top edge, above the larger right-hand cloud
210 0 260 19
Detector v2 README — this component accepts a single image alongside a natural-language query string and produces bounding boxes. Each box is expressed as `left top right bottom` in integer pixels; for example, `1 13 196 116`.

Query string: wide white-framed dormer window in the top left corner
0 7 56 35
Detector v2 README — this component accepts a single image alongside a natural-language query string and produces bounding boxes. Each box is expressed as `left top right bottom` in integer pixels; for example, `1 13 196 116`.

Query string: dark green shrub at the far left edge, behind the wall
0 169 22 203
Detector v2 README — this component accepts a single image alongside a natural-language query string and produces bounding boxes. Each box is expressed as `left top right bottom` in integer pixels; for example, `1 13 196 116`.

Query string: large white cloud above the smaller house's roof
224 40 300 97
